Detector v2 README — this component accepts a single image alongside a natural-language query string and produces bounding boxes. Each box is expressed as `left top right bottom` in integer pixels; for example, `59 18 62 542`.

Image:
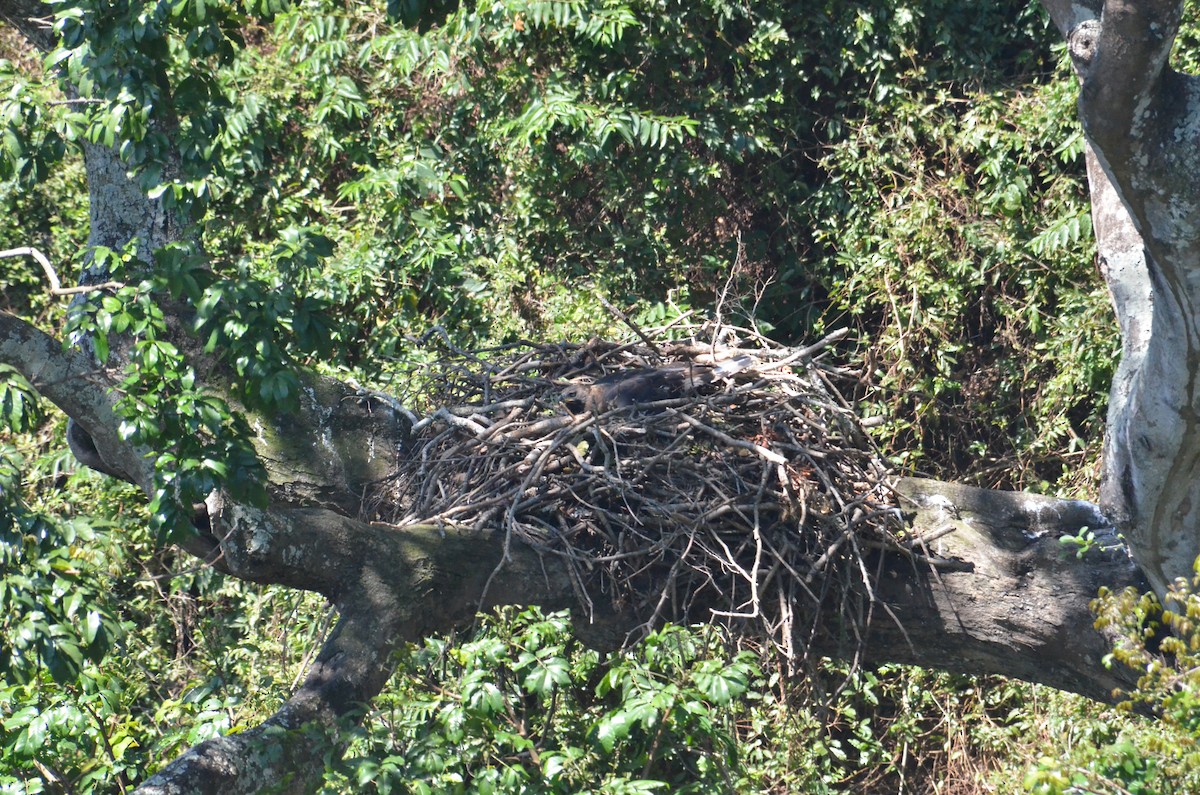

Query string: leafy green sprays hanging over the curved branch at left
63 240 276 542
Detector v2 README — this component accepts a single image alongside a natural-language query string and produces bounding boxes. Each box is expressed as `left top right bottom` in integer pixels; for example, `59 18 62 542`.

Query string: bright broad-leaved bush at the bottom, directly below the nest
333 609 762 795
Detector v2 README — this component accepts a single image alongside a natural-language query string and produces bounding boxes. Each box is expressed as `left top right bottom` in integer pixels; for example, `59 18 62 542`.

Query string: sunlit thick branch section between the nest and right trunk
866 479 1147 701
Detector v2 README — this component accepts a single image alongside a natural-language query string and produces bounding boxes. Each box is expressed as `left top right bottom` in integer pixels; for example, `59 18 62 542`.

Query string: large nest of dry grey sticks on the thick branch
378 328 899 659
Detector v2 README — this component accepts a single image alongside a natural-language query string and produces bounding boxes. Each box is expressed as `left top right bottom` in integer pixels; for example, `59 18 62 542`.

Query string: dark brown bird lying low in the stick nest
563 355 754 414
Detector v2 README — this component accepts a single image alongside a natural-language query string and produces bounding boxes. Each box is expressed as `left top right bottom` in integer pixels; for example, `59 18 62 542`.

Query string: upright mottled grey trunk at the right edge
1044 0 1200 594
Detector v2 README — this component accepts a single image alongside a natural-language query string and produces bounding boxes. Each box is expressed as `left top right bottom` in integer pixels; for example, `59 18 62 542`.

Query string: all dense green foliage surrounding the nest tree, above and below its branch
0 0 1200 793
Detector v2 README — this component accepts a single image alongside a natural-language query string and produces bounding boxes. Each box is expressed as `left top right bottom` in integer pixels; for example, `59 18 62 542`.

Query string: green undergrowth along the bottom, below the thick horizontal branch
0 420 1200 795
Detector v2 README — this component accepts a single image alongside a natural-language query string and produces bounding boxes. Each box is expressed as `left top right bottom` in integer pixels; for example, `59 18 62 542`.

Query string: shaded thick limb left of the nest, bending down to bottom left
137 509 632 795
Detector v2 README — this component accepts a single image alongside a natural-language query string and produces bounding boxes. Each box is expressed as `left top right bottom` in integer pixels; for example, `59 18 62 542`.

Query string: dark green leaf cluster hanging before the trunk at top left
38 0 243 217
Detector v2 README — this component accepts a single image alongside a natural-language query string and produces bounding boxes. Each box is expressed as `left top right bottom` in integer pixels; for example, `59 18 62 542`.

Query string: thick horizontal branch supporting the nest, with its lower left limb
138 480 1145 795
